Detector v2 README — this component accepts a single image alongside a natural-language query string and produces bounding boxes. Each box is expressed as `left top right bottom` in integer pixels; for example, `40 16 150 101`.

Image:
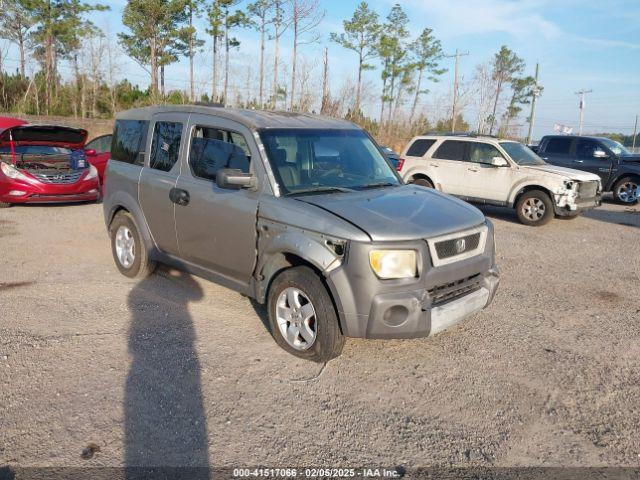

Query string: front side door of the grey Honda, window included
176 115 260 285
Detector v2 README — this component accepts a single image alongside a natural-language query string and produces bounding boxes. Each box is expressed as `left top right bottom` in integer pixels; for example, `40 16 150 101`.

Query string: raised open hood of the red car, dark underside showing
0 125 87 149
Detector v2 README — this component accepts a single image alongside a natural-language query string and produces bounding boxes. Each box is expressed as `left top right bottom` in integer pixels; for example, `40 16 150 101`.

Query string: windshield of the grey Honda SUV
260 129 400 194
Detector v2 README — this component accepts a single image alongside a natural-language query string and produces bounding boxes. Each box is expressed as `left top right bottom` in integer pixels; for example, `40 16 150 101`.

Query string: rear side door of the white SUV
426 140 469 196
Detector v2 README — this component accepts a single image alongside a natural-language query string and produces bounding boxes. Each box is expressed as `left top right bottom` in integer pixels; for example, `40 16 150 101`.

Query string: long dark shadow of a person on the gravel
124 270 210 479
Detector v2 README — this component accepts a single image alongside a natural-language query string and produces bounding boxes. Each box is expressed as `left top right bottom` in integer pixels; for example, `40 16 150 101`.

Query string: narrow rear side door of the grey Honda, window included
139 113 187 255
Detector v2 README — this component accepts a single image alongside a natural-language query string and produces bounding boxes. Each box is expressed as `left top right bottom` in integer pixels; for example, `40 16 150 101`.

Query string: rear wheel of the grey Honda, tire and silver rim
109 212 156 279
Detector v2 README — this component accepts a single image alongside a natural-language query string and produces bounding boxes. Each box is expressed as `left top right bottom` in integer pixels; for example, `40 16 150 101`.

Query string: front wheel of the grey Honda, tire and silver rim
268 266 345 363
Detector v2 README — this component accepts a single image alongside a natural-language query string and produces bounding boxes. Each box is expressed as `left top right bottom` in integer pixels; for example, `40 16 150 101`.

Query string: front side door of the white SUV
465 142 513 204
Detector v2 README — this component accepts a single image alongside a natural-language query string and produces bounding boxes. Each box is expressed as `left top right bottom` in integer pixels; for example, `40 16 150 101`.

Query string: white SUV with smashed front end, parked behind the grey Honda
397 134 602 225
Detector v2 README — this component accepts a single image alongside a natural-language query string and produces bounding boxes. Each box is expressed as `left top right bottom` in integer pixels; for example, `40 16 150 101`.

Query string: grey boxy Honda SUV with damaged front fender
104 106 499 362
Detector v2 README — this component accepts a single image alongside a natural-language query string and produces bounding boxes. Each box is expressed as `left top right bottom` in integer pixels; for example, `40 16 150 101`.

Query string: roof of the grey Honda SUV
116 105 359 129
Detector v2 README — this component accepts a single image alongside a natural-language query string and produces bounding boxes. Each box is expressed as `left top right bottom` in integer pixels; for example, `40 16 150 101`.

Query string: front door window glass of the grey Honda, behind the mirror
189 126 251 181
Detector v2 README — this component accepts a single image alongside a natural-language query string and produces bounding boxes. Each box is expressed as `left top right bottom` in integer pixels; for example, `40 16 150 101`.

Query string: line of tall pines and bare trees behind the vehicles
0 0 541 141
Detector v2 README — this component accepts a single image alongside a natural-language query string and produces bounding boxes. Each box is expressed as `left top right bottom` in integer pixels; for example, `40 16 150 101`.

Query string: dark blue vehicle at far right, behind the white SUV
536 135 640 204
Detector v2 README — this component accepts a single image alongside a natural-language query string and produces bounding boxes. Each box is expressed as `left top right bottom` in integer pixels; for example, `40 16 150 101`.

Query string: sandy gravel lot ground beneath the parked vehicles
0 199 640 468
